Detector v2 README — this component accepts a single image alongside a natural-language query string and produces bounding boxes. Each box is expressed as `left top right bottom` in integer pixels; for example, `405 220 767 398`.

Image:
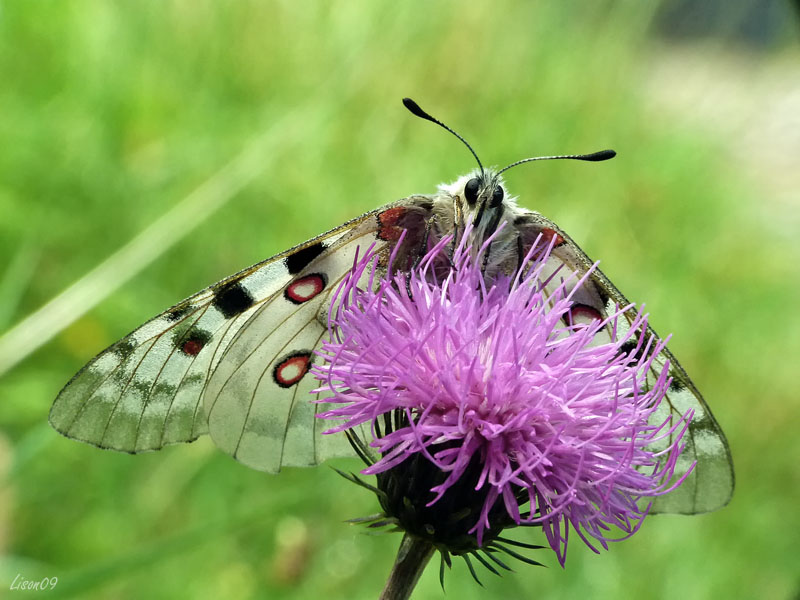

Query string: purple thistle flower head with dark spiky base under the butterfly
313 233 691 570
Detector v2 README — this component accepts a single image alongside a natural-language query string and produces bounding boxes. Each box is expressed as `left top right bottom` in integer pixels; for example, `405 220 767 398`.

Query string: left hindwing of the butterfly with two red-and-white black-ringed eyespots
203 197 429 473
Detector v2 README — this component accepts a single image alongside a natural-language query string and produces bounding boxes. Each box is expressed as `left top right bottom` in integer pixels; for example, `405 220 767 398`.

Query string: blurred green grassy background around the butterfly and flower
0 0 800 600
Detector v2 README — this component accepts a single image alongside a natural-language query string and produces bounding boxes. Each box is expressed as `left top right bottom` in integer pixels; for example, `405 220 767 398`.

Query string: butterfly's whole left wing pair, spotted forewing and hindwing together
50 197 429 471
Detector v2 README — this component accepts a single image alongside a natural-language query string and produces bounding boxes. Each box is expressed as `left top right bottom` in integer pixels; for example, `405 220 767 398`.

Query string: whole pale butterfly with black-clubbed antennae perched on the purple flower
50 98 734 514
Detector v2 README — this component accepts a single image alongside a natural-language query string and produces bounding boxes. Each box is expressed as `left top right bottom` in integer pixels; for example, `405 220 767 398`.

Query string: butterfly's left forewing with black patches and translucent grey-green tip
50 202 422 453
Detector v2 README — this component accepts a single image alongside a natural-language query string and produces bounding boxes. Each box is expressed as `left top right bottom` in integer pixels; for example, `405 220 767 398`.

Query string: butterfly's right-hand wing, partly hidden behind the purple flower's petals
515 212 734 514
